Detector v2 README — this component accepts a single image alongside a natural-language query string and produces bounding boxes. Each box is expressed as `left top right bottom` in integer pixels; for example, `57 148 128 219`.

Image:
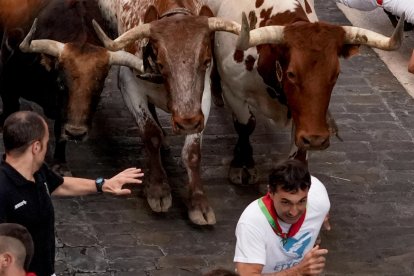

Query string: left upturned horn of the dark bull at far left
19 18 65 57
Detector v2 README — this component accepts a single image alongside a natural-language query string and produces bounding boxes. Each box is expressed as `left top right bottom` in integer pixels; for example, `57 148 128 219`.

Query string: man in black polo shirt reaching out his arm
0 111 144 276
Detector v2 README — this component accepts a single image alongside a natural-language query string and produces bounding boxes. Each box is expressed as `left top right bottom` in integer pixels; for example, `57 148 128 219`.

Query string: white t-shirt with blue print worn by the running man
234 176 330 273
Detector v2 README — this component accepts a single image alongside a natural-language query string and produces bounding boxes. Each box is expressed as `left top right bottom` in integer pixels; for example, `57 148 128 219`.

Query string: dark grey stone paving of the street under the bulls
0 0 414 276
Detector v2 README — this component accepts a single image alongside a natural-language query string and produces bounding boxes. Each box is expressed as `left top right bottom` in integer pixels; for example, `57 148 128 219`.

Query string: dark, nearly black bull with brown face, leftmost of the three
0 0 142 172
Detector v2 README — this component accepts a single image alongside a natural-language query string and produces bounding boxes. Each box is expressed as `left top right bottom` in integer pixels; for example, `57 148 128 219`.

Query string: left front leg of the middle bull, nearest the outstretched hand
119 67 172 212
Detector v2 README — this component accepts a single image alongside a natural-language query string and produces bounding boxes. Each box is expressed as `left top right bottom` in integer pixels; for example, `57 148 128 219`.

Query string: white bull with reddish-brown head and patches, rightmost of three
206 0 402 184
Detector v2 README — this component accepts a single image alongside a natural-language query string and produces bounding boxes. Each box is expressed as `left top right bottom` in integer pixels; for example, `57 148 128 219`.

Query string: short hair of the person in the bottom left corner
0 223 34 271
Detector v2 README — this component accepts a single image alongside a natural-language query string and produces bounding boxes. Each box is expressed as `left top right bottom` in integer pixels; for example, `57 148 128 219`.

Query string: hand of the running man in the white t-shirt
297 245 328 276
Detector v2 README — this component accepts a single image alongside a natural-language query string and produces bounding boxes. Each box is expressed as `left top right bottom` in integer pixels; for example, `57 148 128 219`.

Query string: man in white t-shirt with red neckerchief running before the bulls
234 160 330 276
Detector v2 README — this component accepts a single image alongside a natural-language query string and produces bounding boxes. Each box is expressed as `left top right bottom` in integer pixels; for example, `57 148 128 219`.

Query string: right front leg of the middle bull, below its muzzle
181 80 216 225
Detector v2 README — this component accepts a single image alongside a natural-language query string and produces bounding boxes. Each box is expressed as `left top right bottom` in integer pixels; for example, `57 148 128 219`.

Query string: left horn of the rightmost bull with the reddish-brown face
236 12 285 51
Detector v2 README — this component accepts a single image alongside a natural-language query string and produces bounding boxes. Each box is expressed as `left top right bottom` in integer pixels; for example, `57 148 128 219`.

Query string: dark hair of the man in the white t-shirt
269 159 311 193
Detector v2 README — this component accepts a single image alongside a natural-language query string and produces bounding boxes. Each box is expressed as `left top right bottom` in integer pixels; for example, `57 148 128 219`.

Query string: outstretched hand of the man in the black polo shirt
102 168 144 195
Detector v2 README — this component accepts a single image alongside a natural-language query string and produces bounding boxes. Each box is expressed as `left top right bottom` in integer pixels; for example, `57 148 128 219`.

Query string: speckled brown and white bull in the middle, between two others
97 0 240 225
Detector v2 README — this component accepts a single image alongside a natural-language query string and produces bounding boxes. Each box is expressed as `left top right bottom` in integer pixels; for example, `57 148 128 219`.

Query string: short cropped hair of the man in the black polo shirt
3 111 46 154
